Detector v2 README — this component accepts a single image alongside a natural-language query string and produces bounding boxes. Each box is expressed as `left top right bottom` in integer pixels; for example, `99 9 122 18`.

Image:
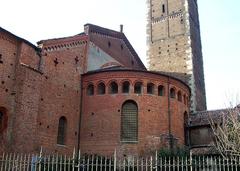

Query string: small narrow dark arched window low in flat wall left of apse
57 116 67 145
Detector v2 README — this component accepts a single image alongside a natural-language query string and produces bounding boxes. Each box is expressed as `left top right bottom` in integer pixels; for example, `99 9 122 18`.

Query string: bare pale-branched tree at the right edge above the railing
209 106 240 158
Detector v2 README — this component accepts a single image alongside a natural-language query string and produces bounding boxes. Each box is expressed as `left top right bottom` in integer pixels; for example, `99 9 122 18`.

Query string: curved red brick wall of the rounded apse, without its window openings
80 71 189 154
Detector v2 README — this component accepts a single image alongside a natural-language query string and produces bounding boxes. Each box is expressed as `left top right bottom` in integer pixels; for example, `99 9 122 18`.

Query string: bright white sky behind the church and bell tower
0 0 240 110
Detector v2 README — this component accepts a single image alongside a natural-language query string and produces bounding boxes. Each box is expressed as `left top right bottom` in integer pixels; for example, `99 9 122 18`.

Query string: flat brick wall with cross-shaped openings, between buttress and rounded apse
37 36 87 154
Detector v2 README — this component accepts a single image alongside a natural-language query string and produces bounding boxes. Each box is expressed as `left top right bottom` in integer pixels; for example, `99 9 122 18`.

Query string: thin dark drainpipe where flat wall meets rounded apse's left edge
77 75 83 157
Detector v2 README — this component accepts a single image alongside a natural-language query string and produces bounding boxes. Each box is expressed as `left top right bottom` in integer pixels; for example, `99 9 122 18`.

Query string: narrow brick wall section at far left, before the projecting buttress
0 32 18 152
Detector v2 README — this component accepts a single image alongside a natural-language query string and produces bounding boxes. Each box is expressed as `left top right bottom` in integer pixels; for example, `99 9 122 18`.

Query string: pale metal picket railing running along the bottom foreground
0 151 240 171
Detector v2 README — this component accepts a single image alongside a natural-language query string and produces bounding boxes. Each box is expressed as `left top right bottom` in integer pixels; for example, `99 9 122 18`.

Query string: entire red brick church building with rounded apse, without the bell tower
0 24 190 154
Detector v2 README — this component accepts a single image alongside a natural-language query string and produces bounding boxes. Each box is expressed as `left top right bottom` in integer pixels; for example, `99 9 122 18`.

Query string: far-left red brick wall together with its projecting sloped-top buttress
0 31 41 152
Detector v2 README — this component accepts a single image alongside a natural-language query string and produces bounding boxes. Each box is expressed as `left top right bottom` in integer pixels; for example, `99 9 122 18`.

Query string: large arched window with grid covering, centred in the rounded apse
121 100 138 142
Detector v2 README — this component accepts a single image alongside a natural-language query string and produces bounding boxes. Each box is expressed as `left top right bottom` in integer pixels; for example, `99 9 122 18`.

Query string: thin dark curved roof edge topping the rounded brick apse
82 69 191 93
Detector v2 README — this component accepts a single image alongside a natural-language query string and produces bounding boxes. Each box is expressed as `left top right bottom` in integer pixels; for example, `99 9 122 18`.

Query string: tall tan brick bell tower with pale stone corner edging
147 0 206 111
